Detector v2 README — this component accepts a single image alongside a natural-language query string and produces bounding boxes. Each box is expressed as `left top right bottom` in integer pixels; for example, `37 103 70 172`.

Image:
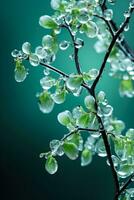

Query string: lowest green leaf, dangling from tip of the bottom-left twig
45 155 58 174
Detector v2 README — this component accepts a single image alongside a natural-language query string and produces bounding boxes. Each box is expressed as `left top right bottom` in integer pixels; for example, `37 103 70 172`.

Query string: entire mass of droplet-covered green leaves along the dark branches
12 0 134 200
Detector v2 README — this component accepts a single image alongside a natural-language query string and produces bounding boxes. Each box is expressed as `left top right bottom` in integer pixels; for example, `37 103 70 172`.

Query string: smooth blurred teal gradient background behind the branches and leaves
0 0 134 200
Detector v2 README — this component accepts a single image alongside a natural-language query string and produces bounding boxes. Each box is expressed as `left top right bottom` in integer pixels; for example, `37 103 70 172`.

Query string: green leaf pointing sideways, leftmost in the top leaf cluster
39 15 58 29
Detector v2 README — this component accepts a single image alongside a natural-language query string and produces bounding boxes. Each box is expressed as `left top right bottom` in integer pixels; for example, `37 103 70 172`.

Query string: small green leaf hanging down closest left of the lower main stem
81 149 92 166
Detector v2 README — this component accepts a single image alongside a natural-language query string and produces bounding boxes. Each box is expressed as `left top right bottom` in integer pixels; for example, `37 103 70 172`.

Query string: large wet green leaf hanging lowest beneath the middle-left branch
38 91 54 113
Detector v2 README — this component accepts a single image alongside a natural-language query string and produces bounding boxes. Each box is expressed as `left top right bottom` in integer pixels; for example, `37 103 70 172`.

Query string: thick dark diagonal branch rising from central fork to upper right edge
91 5 134 90
